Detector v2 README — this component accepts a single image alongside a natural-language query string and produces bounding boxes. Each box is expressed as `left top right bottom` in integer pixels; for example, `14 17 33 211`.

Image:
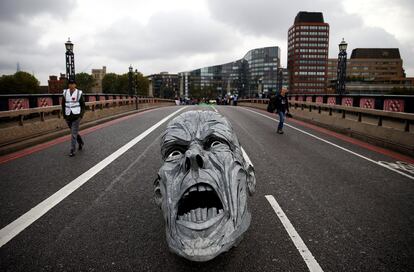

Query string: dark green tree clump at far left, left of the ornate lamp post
0 71 40 94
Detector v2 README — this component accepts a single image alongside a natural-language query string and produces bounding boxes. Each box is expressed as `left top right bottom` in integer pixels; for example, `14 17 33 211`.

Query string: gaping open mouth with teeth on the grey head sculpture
177 183 224 230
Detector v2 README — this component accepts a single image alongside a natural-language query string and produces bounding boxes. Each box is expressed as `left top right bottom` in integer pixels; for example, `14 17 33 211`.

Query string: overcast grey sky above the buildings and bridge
0 0 414 85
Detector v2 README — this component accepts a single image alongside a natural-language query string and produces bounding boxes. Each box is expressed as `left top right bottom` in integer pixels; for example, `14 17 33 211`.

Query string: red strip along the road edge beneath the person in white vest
0 109 155 164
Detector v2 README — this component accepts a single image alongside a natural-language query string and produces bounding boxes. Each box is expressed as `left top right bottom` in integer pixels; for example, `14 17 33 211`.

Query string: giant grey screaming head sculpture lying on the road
155 111 256 261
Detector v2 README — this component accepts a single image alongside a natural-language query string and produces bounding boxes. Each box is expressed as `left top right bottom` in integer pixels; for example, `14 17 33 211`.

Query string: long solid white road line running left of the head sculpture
0 107 184 247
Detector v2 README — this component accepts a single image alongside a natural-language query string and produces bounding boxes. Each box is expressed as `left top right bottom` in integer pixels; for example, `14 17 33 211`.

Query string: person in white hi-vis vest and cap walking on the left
62 79 85 157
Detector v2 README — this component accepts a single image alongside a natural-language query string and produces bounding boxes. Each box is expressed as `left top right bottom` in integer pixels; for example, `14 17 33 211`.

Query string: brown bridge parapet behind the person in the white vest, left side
0 95 175 154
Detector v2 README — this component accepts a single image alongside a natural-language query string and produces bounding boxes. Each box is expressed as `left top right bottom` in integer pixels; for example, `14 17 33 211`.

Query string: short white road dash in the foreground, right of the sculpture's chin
265 195 323 272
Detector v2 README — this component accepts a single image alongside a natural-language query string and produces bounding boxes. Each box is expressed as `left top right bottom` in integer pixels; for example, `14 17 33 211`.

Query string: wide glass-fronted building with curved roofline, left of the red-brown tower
179 46 281 98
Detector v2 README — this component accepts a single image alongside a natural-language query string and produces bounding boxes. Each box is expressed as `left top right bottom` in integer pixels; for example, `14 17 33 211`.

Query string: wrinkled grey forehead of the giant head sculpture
163 111 235 144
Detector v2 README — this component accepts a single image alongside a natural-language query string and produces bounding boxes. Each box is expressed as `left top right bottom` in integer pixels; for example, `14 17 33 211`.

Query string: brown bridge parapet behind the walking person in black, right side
239 98 414 156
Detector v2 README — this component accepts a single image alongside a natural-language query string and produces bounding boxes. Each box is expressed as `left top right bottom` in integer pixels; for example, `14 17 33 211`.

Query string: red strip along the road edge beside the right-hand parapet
249 109 414 164
